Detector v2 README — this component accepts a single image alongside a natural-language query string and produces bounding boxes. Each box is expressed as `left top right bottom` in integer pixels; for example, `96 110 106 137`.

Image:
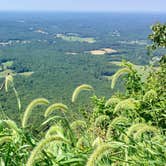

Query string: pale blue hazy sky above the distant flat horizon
0 0 166 12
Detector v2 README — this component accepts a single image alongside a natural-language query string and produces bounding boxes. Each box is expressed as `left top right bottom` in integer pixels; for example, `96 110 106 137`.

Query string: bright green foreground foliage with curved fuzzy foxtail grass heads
0 23 166 166
